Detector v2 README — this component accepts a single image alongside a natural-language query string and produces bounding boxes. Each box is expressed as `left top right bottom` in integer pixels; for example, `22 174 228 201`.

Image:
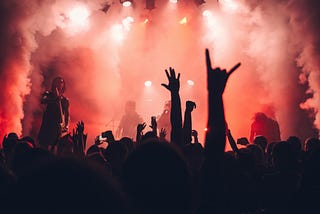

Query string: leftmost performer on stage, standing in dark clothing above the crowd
38 77 69 150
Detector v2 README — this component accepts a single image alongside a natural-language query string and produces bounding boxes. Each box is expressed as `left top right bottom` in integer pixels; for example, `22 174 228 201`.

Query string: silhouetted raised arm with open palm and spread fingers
161 67 183 146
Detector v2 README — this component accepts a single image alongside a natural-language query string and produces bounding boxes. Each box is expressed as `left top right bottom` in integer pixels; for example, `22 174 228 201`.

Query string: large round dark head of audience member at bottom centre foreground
122 142 192 214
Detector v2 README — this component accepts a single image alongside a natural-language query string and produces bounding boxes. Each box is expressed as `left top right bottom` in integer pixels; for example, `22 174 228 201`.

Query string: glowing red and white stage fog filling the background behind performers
0 0 320 144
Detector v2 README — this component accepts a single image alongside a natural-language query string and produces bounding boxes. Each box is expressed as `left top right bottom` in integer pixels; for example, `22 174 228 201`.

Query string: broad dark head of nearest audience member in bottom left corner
10 158 128 214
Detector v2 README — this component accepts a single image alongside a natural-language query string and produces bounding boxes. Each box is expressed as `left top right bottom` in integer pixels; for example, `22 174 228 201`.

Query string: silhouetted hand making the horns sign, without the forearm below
206 49 241 95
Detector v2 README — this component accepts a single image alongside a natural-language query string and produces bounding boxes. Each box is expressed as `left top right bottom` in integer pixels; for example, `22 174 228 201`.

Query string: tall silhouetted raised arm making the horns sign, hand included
205 49 241 158
